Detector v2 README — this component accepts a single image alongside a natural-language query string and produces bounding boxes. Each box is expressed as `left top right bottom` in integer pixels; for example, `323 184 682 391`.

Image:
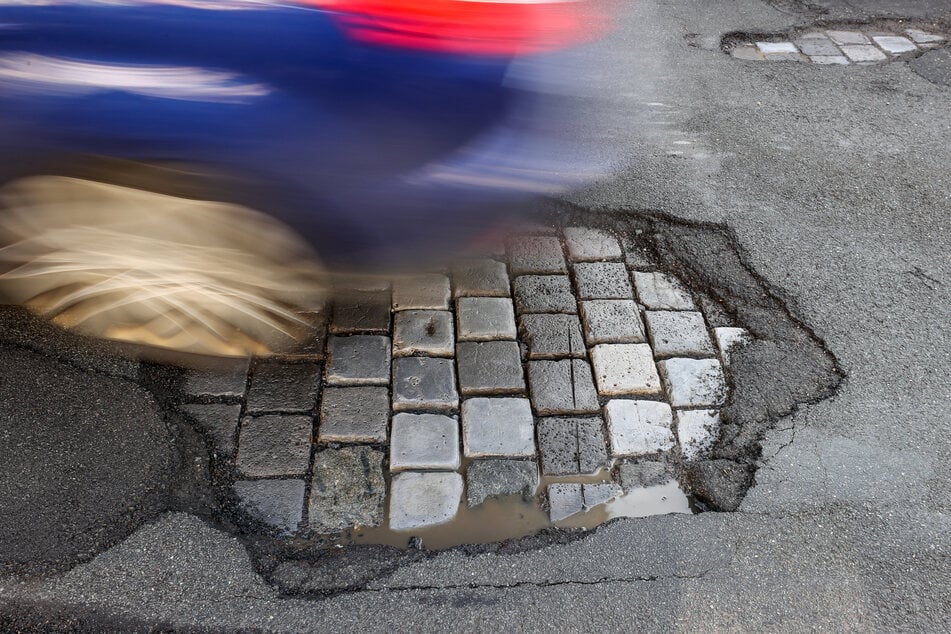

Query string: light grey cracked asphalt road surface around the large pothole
0 0 951 632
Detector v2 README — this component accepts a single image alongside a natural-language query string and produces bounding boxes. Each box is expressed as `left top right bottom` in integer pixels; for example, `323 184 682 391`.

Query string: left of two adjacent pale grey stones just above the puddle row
390 414 461 471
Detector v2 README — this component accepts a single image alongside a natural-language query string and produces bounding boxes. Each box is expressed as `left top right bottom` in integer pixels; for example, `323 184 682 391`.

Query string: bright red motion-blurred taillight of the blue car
305 0 606 55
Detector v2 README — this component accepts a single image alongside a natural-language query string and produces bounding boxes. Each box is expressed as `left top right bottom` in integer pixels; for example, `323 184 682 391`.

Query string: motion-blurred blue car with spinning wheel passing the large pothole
0 0 607 352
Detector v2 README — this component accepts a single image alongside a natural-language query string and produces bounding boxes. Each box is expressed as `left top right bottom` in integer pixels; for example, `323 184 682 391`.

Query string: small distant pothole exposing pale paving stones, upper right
721 23 948 66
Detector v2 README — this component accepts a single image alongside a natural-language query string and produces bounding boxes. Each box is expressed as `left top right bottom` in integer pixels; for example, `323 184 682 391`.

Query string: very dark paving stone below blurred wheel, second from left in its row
247 361 320 414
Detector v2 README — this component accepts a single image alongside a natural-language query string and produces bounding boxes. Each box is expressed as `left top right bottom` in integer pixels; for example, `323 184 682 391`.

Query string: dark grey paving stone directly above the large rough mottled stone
317 387 390 443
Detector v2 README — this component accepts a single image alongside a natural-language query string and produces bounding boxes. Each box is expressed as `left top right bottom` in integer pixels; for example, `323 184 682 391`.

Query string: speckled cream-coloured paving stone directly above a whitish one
591 343 660 396
